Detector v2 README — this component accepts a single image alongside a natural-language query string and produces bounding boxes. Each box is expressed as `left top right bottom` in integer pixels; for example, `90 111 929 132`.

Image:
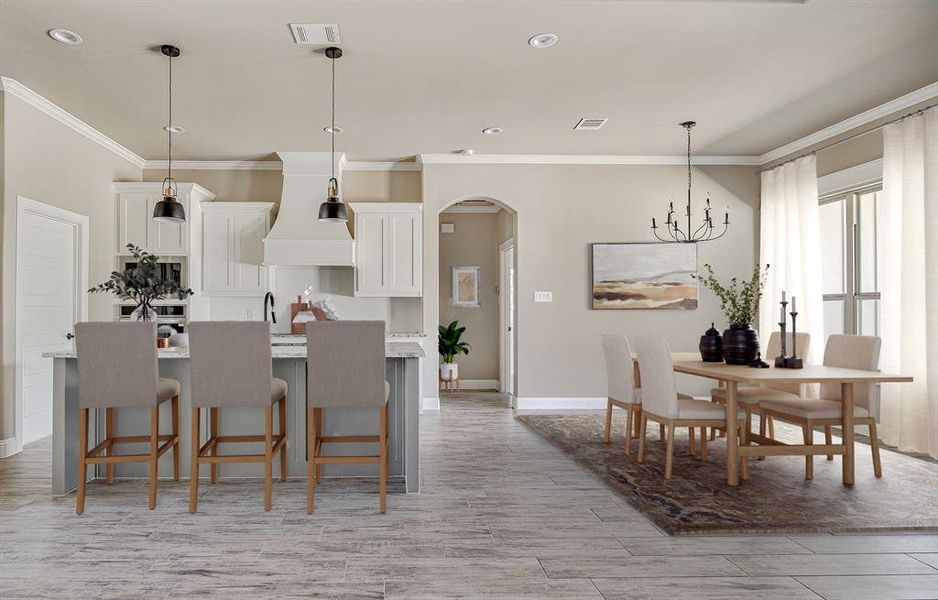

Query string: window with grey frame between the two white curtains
820 183 883 337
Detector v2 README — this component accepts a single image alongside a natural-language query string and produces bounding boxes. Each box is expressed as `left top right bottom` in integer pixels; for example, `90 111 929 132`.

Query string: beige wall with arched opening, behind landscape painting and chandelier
423 165 759 398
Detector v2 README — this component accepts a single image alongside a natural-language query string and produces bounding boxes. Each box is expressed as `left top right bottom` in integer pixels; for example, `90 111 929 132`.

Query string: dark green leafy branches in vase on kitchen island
88 244 194 321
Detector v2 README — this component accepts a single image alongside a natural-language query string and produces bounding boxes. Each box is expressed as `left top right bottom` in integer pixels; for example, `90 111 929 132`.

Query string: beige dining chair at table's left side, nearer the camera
635 338 744 479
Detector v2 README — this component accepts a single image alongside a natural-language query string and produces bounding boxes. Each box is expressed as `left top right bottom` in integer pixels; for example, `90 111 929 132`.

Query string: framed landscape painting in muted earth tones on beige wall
591 243 697 310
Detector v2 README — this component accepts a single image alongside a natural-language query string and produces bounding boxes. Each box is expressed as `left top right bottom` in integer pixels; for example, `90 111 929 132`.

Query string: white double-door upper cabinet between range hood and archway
350 202 423 297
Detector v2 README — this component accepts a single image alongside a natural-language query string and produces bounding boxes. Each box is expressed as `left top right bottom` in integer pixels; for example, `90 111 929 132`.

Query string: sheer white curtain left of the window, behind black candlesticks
759 155 824 364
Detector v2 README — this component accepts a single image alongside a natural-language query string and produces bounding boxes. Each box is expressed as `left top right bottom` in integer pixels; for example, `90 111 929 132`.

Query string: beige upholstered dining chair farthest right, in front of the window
759 335 883 479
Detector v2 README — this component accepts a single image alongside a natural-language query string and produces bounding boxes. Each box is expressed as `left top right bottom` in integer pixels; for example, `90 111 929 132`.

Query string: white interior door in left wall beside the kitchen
16 199 87 444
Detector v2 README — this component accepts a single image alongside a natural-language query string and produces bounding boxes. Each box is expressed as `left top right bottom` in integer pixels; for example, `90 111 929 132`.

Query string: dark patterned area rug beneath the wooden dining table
518 410 938 534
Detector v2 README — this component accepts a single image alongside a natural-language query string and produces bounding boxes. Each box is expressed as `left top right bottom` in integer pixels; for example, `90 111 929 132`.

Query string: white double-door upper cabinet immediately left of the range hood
202 202 273 296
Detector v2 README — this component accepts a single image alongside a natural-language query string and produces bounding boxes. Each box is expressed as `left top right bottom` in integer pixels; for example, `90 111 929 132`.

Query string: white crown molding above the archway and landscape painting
417 154 759 166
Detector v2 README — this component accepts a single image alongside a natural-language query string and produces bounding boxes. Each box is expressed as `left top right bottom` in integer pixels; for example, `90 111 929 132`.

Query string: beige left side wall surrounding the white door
0 94 143 439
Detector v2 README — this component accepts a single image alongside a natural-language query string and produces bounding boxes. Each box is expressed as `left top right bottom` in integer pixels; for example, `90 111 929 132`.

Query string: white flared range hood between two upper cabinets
264 152 355 267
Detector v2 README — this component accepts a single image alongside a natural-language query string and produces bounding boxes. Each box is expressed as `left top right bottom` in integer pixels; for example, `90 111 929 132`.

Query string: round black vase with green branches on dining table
693 265 769 365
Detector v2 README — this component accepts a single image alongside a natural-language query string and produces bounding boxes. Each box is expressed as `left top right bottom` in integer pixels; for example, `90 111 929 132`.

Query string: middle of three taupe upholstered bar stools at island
189 321 287 513
